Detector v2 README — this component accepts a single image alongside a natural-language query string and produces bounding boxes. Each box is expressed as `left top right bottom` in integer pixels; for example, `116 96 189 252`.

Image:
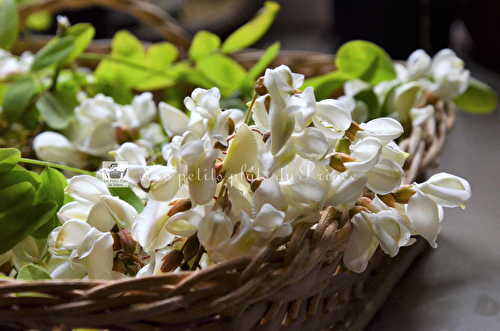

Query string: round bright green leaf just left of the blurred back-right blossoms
335 40 396 85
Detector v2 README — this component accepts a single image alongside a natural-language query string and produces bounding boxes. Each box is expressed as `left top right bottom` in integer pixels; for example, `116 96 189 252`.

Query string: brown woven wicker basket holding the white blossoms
0 0 454 331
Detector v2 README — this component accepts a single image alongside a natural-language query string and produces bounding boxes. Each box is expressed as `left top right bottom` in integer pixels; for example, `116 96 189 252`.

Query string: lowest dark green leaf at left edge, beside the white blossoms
0 201 57 254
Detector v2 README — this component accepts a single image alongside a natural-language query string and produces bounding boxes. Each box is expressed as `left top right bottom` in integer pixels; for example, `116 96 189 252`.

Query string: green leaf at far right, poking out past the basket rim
453 78 498 114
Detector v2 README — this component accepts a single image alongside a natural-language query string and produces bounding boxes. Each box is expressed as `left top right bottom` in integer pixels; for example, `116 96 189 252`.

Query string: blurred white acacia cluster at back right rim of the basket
339 49 470 126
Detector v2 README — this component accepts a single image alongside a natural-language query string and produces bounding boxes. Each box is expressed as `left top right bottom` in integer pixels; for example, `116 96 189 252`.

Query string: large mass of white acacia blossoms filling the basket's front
3 65 471 279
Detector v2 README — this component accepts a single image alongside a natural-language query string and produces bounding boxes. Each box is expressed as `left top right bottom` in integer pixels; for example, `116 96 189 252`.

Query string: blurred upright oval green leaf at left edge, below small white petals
2 76 36 123
